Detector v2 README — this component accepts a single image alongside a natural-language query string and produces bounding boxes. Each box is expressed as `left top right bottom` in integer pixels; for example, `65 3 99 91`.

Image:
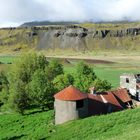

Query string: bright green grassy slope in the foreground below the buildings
0 108 140 140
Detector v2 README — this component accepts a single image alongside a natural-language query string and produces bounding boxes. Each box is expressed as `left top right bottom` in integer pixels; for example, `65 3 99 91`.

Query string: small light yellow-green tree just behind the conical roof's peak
53 74 74 91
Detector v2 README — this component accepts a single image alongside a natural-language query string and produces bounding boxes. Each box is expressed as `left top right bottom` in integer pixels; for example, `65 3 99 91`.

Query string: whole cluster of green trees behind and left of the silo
0 53 111 114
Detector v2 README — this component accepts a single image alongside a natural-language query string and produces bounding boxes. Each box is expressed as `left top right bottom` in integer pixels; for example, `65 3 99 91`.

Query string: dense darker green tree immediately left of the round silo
29 69 54 110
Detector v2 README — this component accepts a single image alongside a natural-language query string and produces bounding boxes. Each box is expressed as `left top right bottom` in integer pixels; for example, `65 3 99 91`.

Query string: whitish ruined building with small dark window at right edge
120 74 140 101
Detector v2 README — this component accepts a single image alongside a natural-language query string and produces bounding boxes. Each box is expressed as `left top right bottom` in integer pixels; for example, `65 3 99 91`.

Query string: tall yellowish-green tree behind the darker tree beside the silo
8 54 48 114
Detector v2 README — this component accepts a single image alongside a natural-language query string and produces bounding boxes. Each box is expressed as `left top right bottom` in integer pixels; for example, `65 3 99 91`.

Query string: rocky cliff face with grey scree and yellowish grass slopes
0 25 140 51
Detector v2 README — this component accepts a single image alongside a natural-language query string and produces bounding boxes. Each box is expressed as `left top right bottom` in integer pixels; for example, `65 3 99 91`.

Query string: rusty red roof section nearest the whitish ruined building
112 89 131 103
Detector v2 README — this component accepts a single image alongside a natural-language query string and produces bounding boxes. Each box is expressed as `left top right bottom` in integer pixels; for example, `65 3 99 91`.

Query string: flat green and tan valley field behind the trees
0 56 140 88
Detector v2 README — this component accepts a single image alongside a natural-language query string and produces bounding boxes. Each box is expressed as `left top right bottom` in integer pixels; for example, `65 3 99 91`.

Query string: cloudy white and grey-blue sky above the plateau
0 0 140 27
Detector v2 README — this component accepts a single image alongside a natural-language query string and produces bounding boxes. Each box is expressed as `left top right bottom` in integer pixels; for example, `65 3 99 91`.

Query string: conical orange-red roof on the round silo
54 86 87 101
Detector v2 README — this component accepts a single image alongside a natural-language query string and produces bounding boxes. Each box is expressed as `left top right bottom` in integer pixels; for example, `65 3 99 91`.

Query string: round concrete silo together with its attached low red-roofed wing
54 86 132 124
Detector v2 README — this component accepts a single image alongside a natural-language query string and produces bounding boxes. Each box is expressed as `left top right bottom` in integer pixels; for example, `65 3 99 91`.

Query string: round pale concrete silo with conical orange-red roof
54 86 88 124
